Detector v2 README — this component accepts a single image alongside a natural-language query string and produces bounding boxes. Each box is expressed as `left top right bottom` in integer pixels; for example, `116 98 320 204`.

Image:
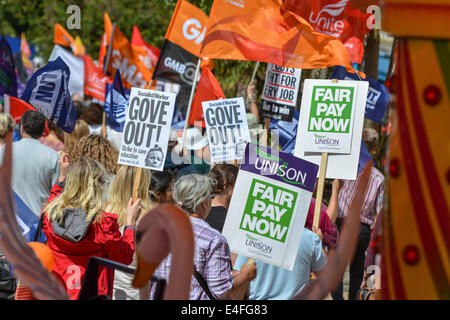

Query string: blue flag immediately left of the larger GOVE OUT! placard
104 70 130 132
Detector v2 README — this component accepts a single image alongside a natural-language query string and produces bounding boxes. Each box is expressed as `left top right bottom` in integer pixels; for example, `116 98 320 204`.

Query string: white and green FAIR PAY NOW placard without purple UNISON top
294 79 368 180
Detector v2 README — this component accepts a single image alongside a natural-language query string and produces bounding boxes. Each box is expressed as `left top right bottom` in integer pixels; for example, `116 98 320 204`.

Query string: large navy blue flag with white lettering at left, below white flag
22 57 77 133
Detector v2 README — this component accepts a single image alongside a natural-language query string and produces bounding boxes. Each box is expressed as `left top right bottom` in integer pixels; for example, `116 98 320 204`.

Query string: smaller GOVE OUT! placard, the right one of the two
202 98 251 163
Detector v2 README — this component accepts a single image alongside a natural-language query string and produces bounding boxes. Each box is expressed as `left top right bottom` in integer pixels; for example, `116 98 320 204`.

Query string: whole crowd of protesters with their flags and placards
0 0 444 300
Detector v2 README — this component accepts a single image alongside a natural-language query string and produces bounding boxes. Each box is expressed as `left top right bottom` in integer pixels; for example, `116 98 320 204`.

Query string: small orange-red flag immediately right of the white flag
83 54 112 101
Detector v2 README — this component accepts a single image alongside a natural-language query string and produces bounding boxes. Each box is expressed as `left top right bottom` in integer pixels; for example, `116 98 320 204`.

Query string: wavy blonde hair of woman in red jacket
44 158 107 223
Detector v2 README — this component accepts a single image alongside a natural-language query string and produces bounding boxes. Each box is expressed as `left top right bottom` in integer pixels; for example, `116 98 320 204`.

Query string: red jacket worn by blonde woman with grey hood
43 184 134 300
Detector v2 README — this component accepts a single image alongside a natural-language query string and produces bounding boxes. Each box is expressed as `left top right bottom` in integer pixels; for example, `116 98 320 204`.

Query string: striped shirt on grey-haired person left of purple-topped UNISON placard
151 217 234 300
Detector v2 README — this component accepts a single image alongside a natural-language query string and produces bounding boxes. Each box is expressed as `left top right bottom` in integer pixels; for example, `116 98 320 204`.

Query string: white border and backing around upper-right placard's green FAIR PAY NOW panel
294 79 369 180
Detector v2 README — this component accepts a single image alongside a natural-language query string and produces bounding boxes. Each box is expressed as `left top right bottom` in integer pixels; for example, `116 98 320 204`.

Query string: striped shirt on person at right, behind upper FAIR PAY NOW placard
338 167 384 226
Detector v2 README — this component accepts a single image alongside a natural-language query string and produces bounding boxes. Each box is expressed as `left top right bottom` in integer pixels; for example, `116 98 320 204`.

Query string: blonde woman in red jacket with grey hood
43 153 140 299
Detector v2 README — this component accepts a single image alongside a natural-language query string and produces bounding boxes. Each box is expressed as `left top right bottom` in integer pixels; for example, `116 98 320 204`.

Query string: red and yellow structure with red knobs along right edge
381 0 450 299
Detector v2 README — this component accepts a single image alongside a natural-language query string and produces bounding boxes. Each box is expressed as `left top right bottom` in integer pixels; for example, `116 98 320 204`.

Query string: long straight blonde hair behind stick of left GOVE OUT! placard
106 165 152 226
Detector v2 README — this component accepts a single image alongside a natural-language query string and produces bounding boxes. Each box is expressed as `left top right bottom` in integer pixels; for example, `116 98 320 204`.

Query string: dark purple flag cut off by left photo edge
0 37 17 104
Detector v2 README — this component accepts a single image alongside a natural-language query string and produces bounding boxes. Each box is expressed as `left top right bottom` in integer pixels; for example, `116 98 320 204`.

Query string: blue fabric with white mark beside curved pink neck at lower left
13 191 47 242
